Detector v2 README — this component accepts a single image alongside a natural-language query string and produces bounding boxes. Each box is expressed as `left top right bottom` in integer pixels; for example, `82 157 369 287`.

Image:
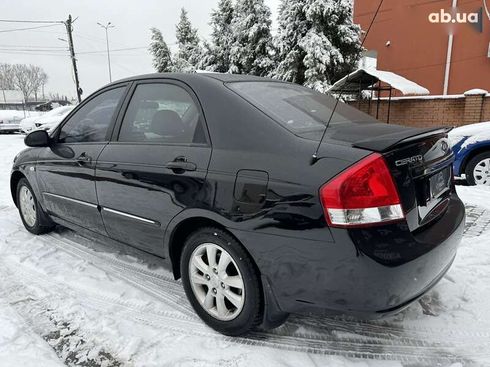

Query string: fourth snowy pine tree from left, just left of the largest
230 0 274 76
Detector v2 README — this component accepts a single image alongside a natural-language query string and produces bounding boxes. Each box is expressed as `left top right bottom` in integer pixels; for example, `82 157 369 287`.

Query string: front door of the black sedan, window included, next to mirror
37 85 126 234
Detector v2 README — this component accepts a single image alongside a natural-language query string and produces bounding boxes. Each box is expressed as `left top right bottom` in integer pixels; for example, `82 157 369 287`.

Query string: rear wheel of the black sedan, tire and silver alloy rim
180 227 263 336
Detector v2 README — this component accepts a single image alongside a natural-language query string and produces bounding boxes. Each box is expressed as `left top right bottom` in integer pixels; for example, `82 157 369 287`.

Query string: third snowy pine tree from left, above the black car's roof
201 0 233 73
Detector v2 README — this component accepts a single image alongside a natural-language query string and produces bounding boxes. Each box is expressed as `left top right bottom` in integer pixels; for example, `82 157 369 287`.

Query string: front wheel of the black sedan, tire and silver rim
16 178 55 235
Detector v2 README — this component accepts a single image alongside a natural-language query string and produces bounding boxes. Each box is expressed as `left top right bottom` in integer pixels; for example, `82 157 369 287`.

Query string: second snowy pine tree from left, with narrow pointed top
173 8 202 72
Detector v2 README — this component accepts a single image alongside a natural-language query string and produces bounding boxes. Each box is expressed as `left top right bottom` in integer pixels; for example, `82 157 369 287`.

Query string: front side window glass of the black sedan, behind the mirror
58 87 125 143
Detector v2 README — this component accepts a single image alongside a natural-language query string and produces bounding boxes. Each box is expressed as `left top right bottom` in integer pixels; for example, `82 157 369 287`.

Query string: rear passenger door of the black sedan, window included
96 79 211 255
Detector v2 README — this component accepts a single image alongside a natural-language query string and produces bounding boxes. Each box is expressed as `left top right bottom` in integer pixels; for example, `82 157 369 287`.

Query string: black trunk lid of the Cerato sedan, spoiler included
308 123 454 231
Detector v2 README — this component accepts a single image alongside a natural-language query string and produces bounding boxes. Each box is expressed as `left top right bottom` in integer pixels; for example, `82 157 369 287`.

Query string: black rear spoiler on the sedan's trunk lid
352 127 453 153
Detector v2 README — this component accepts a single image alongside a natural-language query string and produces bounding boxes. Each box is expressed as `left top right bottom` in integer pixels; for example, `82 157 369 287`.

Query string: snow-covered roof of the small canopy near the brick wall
329 68 430 96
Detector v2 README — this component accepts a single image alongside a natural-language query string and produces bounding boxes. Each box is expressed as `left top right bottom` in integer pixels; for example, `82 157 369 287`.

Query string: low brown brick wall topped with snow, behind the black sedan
350 94 490 127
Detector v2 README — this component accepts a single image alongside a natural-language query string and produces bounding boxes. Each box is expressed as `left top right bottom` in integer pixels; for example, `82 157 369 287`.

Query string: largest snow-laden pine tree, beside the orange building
273 0 362 92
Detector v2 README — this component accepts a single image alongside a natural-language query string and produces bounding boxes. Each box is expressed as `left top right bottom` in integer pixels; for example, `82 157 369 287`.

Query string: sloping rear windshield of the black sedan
227 81 376 134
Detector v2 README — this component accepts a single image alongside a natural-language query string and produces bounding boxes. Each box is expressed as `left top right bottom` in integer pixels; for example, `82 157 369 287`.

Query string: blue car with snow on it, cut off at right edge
449 122 490 186
